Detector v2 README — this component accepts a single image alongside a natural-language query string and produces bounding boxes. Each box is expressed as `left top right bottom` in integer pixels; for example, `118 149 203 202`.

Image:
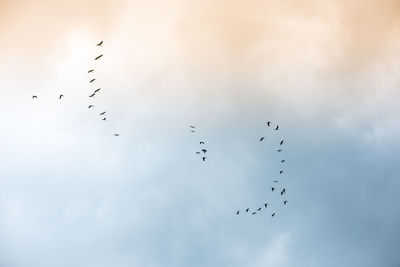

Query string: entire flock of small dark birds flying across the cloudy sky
32 41 288 220
